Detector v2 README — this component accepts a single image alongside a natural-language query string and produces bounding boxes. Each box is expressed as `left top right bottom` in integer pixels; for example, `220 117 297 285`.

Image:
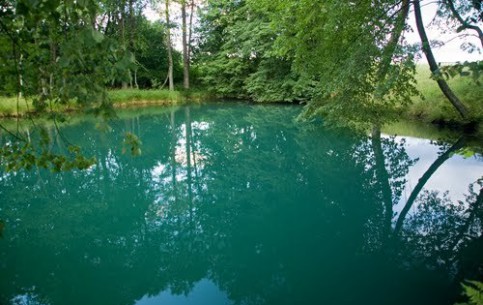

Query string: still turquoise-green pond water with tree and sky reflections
0 104 483 305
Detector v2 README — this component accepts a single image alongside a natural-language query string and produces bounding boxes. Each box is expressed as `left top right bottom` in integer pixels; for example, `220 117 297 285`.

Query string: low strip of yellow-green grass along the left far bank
0 89 210 117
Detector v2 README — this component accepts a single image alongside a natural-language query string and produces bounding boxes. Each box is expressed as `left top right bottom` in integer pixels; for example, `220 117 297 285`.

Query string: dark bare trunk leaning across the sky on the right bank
413 0 468 119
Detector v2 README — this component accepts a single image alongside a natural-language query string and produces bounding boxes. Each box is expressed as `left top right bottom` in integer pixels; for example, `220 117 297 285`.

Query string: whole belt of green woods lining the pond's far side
0 0 483 171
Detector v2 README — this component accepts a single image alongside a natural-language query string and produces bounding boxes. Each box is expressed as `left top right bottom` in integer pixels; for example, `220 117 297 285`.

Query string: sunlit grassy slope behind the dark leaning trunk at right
406 65 483 122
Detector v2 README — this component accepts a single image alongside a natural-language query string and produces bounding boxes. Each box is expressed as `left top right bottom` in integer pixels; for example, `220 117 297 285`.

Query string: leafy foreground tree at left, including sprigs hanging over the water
0 0 133 170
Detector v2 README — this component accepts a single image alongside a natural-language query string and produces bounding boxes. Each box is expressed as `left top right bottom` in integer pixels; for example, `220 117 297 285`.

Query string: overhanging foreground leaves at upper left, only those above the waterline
0 0 129 110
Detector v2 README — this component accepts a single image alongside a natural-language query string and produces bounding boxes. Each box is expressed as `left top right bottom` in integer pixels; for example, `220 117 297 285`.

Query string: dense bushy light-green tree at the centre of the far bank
197 0 313 102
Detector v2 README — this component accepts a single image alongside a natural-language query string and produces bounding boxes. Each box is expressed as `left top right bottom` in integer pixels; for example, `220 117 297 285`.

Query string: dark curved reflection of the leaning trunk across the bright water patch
394 137 465 235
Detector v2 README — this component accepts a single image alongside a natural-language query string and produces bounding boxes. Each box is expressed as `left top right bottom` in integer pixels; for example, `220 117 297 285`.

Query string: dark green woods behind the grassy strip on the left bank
0 0 182 101
